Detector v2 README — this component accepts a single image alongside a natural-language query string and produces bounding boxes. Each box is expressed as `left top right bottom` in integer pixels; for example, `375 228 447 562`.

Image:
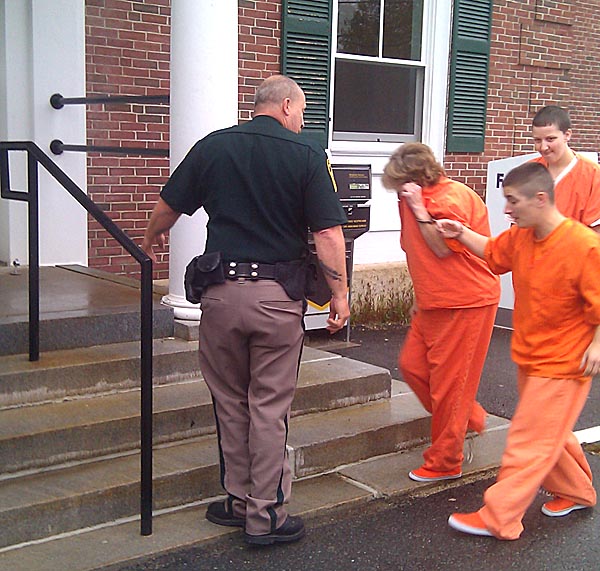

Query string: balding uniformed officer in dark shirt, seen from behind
142 75 350 545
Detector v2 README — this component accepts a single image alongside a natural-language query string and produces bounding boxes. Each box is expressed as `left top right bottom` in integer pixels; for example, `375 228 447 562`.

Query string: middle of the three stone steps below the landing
0 349 391 474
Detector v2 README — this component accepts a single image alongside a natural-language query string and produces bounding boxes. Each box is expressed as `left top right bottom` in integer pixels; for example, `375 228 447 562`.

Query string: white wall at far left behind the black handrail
0 0 87 265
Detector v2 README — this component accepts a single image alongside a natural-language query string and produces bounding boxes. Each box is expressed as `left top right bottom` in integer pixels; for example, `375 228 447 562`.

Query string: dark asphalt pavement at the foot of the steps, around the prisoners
111 327 600 571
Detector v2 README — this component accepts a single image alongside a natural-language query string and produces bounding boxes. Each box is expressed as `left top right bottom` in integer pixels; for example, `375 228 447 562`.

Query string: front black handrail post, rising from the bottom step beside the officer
140 258 153 535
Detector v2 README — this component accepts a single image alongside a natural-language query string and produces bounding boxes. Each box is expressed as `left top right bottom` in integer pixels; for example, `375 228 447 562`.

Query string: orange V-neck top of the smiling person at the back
533 153 600 227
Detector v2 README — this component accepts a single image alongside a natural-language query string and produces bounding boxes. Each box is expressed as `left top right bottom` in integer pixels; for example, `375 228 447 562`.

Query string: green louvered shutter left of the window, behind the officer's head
281 0 332 147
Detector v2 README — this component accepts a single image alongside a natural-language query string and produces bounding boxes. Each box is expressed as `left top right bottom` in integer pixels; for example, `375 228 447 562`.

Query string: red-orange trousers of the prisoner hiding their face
399 305 496 471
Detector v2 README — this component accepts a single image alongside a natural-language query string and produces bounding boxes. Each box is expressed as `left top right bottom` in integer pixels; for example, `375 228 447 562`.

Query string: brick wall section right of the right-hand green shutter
444 0 600 199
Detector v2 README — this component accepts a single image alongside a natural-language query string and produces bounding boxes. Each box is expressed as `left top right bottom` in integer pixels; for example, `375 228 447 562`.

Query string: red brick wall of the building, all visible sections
85 0 600 278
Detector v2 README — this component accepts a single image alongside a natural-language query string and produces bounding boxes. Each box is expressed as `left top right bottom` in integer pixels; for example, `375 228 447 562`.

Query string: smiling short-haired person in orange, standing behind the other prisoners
532 105 600 232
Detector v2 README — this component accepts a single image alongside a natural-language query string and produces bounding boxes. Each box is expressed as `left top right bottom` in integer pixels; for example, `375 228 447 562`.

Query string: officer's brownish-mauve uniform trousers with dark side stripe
200 279 304 535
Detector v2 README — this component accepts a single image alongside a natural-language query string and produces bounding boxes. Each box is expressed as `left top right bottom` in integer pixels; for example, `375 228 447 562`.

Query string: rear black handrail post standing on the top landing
27 151 40 361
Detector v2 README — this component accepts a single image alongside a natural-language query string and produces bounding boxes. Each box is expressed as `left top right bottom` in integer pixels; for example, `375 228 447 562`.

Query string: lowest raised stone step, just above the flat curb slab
0 393 429 547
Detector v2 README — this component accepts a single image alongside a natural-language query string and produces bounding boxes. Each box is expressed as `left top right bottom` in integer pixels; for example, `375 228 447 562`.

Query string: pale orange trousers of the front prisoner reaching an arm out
479 370 596 539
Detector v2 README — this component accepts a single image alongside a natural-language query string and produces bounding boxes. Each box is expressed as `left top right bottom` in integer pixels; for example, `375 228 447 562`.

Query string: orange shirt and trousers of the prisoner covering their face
398 177 500 472
